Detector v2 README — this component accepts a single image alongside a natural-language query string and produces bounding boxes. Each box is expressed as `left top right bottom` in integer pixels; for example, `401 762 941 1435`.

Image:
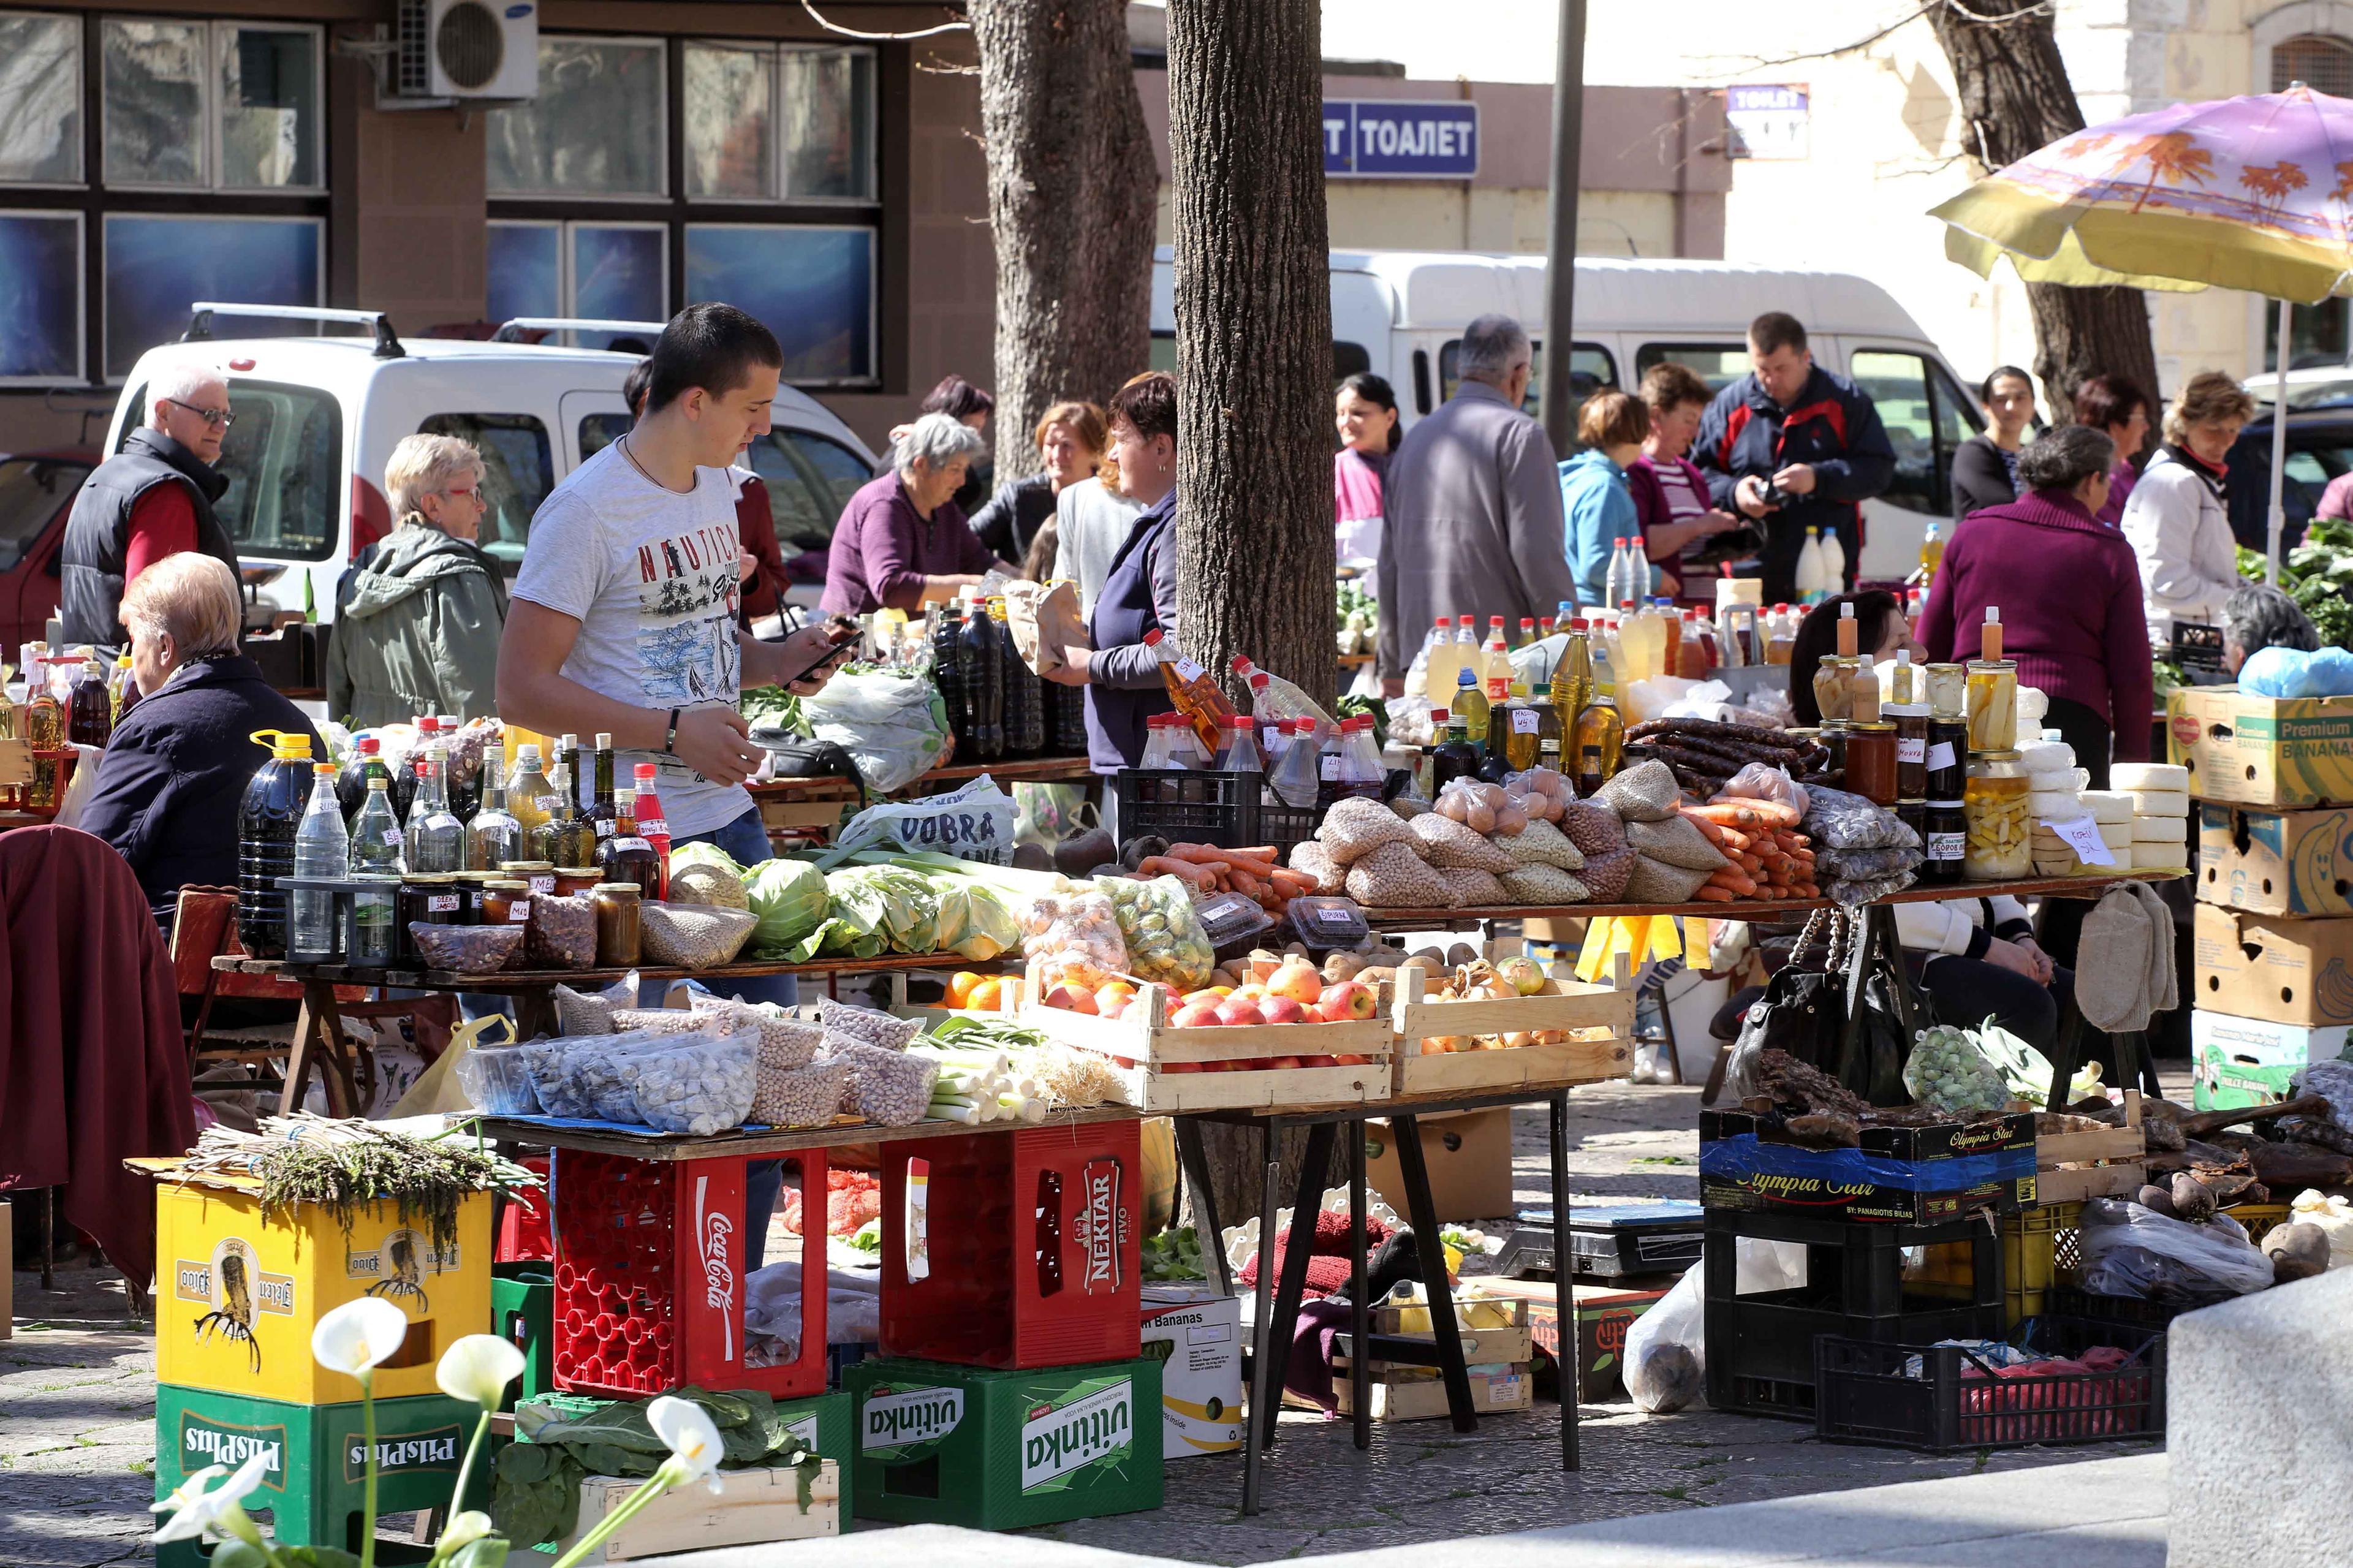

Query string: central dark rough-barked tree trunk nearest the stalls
1167 0 1336 1224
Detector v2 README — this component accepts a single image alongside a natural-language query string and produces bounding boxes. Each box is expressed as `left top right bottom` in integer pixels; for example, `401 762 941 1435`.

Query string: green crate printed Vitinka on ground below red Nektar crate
843 1356 1162 1531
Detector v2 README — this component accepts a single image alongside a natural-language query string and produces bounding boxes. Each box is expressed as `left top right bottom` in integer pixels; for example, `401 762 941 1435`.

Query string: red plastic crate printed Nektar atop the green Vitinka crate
882 1121 1141 1368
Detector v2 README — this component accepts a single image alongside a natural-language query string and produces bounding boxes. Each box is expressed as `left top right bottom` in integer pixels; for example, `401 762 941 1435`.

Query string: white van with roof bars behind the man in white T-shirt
106 306 875 621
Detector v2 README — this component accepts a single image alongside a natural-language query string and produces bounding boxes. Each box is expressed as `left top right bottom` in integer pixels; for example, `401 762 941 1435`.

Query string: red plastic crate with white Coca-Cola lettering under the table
553 1149 826 1398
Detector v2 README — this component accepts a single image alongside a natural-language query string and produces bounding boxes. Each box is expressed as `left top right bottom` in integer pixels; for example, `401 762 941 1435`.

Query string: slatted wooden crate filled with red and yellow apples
1023 958 1395 1113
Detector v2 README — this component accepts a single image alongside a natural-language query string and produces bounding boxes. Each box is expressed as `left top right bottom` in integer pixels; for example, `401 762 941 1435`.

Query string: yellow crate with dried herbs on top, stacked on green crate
155 1175 490 1406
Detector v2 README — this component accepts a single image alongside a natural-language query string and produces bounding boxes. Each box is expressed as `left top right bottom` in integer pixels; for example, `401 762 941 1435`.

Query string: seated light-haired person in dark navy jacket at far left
82 553 327 928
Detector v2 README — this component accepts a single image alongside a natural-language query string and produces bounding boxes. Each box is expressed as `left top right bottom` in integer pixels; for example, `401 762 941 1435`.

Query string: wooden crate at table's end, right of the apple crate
1390 953 1633 1095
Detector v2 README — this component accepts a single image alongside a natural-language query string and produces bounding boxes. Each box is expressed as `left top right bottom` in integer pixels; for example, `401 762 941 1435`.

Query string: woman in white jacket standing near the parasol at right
2120 369 2254 640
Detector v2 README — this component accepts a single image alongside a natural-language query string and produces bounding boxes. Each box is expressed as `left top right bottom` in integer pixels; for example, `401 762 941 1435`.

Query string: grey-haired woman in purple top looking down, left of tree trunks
824 414 1019 615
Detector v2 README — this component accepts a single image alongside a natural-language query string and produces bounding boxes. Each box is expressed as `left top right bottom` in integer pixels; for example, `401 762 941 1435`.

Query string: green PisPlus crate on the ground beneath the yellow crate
155 1384 492 1568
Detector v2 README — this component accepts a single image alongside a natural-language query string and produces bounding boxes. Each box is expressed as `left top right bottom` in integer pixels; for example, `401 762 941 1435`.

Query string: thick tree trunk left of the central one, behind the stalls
969 0 1158 480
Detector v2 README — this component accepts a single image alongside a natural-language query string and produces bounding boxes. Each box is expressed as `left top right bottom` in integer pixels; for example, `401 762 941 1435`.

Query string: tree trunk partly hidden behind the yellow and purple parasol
1927 0 2158 442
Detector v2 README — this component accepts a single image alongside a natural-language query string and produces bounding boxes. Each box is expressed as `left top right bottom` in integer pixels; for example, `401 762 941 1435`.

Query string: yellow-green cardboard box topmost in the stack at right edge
2165 685 2353 805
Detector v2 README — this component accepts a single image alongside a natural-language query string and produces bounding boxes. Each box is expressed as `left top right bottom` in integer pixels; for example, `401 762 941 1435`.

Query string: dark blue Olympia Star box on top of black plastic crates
1699 1112 2036 1224
